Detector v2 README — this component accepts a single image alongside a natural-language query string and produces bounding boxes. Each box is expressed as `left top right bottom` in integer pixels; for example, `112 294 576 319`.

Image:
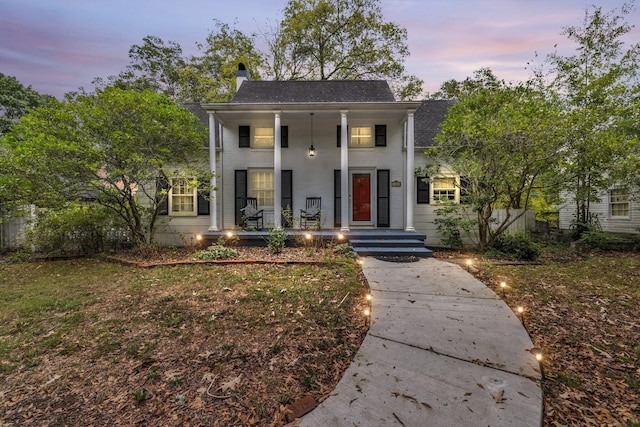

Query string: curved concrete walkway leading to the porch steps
300 258 542 427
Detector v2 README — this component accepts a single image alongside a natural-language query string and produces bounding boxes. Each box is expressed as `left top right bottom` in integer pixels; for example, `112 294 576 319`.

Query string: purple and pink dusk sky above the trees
0 0 640 97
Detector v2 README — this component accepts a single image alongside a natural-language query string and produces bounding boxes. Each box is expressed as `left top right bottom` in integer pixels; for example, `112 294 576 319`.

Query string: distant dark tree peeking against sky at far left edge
0 73 54 135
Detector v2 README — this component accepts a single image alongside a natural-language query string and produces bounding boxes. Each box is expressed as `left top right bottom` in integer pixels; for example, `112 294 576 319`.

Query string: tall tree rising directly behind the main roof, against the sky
269 0 422 99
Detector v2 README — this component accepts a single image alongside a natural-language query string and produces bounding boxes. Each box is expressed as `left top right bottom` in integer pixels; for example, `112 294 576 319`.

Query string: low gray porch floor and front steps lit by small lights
202 229 433 258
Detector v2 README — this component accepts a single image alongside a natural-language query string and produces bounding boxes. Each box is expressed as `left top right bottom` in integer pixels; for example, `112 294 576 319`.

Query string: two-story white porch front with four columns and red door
203 102 424 233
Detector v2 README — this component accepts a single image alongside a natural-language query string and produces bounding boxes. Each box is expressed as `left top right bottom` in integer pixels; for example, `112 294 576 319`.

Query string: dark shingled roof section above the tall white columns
231 80 395 104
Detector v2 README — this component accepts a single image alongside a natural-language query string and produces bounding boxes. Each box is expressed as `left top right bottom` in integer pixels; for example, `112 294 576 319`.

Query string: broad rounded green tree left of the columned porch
0 88 207 243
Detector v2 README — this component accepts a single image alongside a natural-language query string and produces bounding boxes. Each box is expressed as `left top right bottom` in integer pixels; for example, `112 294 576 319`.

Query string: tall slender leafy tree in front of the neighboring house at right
548 5 640 231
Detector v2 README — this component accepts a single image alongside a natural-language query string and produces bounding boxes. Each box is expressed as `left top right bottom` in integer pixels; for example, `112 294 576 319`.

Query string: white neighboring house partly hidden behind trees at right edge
559 187 640 234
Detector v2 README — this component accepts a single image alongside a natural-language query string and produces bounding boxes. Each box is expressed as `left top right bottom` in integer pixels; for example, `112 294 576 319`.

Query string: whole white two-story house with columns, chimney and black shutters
156 66 468 252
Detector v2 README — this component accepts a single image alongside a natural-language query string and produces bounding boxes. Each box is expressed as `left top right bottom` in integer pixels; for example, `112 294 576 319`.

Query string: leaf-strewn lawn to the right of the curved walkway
476 252 640 427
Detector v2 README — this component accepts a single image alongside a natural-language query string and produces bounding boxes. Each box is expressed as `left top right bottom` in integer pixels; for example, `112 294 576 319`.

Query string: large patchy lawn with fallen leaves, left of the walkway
0 252 367 426
